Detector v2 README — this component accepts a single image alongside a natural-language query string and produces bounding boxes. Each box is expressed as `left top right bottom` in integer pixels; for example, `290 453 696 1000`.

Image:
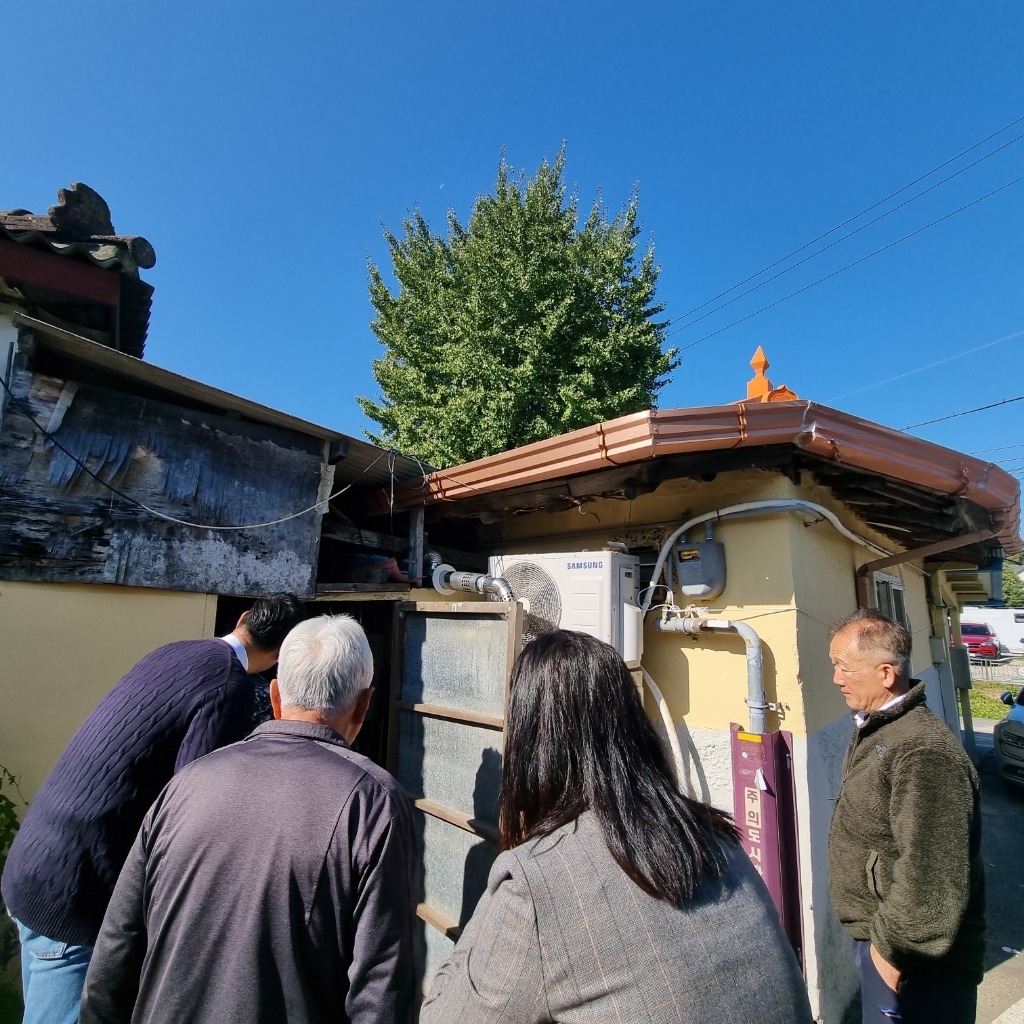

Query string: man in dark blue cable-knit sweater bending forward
2 594 305 1024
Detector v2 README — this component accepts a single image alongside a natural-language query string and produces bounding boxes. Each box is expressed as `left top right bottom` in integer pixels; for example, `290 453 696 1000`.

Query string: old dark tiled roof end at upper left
0 182 157 356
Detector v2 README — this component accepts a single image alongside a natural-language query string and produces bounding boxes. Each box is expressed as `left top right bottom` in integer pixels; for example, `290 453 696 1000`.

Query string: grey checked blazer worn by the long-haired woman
420 812 811 1024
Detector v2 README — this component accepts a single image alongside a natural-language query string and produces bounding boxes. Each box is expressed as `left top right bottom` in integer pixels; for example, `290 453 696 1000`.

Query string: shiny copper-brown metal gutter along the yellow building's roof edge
387 401 1021 551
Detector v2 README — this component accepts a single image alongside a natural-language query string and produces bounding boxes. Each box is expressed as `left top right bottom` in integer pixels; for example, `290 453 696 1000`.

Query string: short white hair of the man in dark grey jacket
278 615 374 715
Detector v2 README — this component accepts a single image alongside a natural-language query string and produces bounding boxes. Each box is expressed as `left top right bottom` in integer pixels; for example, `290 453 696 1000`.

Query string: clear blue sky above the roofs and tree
0 0 1024 469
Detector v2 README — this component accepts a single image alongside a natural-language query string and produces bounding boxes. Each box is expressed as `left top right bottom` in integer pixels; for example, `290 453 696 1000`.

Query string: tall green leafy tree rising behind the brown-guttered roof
358 145 678 468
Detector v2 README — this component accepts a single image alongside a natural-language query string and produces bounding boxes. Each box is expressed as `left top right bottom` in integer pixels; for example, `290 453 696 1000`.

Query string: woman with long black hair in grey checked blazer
420 630 811 1024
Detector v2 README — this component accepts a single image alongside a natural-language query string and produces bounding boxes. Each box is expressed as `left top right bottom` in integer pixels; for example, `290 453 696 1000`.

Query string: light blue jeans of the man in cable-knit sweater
13 918 92 1024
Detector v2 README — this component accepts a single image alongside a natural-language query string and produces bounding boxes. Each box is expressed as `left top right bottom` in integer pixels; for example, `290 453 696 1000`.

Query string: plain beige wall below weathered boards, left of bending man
0 581 217 800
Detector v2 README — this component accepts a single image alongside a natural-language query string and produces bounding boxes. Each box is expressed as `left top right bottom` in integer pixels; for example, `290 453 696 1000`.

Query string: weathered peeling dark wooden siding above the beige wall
0 371 322 597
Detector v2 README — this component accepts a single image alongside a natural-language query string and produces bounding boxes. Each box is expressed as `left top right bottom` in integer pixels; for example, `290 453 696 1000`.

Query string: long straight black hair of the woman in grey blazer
499 630 738 904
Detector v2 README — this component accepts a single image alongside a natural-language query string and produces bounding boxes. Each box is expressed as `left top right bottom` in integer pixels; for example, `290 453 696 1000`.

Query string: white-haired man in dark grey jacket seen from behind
80 615 416 1024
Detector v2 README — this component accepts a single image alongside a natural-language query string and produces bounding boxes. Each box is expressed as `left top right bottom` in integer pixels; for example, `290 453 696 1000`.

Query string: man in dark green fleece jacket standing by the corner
828 609 985 1024
